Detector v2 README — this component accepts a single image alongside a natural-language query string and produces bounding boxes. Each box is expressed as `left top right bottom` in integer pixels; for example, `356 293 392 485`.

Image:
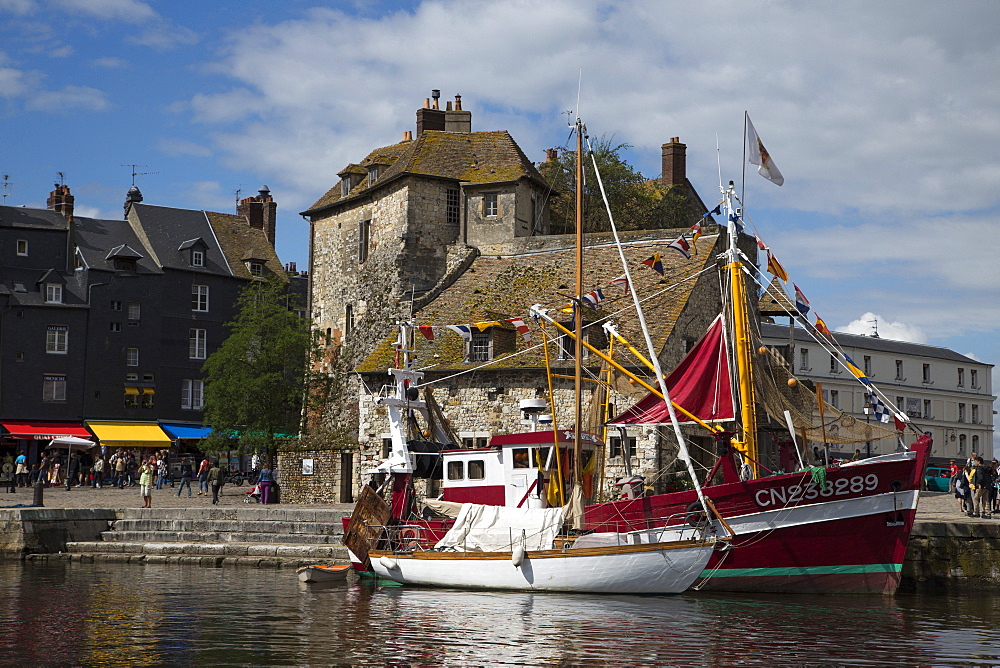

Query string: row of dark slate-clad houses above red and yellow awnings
0 185 306 461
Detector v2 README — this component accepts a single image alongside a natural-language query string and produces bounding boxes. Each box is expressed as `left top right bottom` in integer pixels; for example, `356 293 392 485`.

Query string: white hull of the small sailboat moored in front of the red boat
370 541 715 594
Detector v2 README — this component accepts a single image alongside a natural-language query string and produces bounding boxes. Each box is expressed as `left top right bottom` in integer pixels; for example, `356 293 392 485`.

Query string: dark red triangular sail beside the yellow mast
608 315 735 425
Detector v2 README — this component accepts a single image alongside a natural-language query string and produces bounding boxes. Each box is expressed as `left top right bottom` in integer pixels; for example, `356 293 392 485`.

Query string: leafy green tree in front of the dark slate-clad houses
202 280 325 467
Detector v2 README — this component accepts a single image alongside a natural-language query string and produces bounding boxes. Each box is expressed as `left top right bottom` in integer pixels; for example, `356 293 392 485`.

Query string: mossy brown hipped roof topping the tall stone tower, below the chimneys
302 130 545 216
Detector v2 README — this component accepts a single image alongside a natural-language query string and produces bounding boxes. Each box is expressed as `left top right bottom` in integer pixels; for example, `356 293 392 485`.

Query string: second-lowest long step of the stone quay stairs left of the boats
66 541 348 562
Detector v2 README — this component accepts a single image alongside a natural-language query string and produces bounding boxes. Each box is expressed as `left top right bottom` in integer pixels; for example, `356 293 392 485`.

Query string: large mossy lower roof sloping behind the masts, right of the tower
356 230 725 372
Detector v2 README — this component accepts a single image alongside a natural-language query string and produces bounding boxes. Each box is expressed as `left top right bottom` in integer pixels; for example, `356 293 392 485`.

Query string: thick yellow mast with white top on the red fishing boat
724 181 759 478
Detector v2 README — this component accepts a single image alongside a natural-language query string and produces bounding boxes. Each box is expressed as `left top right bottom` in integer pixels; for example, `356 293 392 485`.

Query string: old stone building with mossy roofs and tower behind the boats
292 96 732 501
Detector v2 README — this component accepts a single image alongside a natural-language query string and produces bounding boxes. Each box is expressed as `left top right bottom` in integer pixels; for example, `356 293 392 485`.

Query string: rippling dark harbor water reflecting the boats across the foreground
0 560 1000 666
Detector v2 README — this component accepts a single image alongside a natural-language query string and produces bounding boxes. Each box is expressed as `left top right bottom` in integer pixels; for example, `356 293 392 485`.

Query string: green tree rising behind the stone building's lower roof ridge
539 137 691 234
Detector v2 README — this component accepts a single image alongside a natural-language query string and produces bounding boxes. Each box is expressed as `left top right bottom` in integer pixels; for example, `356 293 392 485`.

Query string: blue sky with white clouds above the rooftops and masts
0 0 1000 448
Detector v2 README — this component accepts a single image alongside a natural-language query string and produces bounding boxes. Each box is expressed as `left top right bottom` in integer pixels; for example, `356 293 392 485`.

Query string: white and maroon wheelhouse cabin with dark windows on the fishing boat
441 429 603 508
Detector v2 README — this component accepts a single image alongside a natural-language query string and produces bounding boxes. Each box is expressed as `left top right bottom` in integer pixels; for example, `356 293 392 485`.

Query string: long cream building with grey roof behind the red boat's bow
761 323 996 459
